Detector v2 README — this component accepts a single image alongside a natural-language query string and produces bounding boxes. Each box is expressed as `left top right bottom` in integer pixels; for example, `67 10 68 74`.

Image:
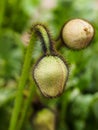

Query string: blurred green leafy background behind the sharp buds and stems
0 0 98 130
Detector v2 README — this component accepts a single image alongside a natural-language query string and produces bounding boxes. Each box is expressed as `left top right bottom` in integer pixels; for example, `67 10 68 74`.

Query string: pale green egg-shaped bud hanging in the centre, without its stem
33 55 68 98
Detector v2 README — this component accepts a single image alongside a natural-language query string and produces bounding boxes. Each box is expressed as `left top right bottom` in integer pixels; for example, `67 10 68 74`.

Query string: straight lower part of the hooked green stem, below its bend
9 33 35 130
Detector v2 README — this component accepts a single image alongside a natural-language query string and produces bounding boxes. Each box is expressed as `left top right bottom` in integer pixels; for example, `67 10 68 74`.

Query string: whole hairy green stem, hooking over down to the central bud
9 24 52 130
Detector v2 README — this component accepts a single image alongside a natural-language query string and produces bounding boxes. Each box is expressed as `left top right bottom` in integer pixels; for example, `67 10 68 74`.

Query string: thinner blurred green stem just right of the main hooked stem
17 81 35 130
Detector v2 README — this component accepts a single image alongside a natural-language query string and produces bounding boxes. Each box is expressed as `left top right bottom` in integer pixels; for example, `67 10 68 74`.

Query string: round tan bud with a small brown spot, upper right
61 19 94 50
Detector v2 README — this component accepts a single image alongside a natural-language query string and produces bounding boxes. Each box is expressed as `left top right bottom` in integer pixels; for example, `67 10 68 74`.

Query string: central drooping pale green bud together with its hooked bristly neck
32 24 69 98
